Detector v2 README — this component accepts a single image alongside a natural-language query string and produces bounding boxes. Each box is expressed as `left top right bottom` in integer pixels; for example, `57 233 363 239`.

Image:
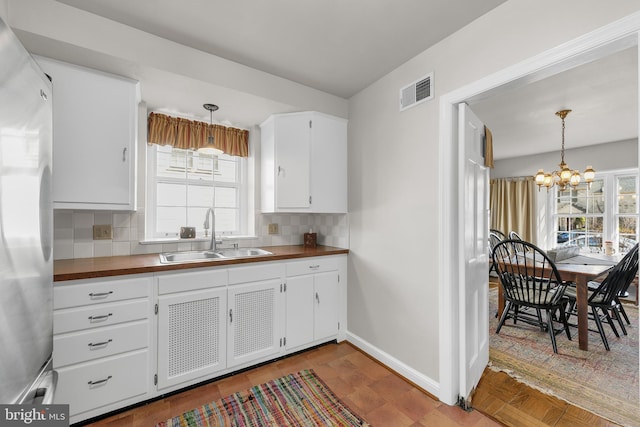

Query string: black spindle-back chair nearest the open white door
492 239 571 353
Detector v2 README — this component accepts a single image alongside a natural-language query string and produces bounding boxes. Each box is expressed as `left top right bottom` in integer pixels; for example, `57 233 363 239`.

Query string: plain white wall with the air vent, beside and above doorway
348 0 640 386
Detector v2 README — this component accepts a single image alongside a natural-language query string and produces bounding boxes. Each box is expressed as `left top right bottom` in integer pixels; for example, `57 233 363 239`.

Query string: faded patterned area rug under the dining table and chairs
489 287 640 426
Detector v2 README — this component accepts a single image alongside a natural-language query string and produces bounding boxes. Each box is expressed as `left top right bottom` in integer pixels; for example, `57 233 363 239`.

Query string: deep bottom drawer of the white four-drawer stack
54 350 151 415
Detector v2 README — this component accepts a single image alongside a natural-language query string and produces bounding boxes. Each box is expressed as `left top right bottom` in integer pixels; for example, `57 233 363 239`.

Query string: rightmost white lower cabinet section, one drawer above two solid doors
285 257 340 350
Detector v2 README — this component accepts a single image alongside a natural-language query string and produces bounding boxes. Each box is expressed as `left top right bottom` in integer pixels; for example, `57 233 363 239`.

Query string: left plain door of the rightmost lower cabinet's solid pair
285 275 314 350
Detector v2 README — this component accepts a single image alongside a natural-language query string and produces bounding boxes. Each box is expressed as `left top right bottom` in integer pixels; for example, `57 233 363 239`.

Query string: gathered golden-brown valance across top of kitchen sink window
147 113 249 157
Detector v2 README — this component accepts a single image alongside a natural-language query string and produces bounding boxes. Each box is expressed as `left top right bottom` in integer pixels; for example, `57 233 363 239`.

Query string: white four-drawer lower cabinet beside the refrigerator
53 275 153 423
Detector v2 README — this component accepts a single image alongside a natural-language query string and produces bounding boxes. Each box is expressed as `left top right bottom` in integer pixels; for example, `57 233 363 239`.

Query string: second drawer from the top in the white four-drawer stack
53 299 149 334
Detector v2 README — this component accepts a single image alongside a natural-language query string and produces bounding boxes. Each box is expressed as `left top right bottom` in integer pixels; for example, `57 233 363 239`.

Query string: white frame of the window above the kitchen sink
145 144 250 242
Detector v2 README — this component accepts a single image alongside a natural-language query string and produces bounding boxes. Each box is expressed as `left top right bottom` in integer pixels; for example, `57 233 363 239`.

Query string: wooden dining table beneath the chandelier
498 254 620 351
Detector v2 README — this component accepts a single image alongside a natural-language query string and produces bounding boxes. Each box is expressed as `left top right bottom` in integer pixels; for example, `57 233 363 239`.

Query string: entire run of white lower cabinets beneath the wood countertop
53 256 346 423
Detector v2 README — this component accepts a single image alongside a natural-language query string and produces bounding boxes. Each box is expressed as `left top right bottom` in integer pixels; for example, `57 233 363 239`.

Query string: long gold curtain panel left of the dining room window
489 177 538 244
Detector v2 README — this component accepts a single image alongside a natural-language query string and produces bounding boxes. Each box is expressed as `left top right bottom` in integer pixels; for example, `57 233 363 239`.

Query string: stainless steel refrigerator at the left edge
0 15 56 404
